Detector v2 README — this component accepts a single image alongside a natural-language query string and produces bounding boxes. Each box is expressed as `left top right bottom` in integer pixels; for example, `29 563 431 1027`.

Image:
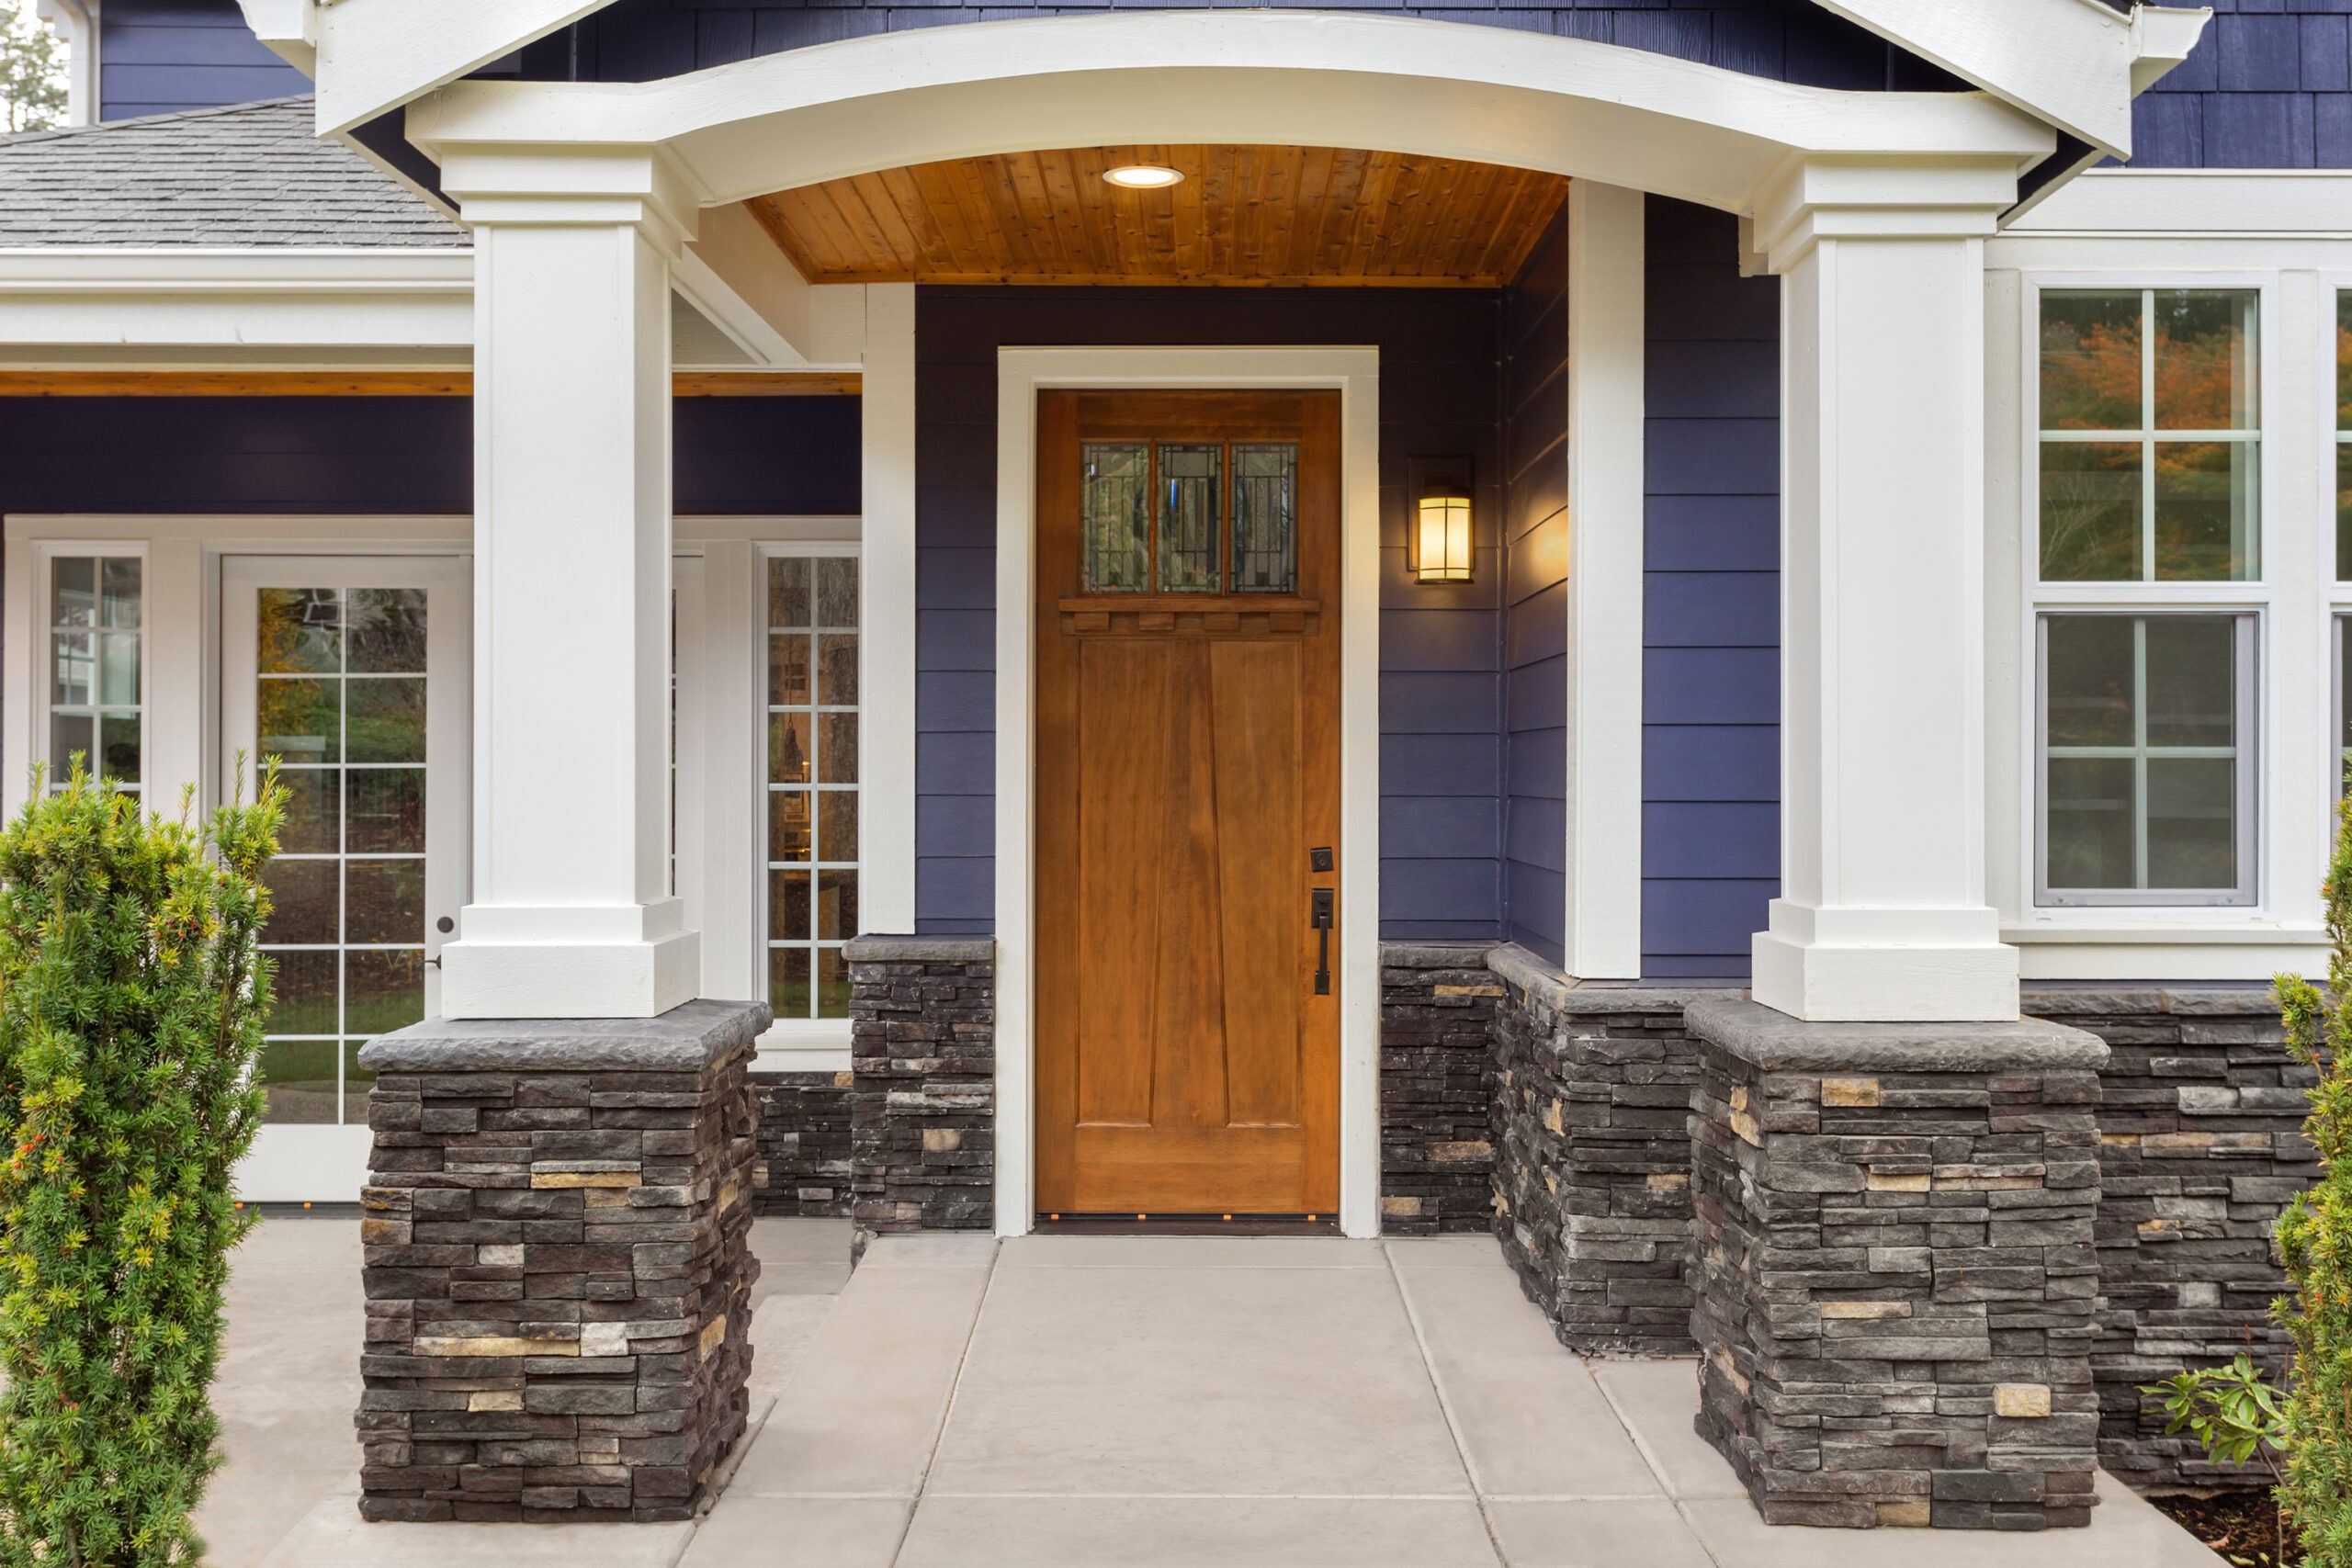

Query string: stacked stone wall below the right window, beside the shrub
2025 985 2319 1491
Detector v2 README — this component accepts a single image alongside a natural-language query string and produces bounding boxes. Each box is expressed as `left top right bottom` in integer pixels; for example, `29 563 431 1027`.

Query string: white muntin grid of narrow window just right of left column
757 541 865 1025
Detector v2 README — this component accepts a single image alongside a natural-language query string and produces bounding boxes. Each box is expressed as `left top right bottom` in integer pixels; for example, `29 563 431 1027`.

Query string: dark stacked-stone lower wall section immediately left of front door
844 936 997 1232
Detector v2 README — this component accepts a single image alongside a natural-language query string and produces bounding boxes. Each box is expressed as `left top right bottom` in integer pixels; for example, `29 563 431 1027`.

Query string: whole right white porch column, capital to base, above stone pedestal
1752 157 2018 1021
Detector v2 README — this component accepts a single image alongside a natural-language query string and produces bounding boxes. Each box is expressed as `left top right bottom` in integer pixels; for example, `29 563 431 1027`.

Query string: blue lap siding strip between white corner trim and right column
1642 197 1781 978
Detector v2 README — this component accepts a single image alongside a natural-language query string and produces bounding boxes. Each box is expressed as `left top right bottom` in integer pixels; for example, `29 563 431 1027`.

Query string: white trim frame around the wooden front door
995 348 1381 1236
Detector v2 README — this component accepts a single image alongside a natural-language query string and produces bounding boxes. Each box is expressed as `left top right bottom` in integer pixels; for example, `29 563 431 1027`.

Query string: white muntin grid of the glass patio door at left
252 585 433 1126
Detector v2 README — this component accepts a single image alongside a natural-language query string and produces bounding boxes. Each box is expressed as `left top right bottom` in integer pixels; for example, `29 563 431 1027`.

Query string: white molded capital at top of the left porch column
442 143 703 259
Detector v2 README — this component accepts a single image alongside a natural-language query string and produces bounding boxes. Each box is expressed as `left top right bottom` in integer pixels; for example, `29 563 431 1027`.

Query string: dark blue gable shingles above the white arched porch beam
522 0 1966 92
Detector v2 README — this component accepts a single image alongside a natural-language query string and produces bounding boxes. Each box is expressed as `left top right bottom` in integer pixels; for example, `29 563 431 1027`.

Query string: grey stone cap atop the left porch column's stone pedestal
360 997 774 1072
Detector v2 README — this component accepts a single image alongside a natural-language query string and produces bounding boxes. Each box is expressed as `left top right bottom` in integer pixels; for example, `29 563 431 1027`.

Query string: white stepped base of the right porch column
1750 898 2018 1022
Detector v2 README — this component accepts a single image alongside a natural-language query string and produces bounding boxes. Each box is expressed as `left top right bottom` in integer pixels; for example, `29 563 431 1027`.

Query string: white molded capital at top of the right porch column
1747 152 2018 273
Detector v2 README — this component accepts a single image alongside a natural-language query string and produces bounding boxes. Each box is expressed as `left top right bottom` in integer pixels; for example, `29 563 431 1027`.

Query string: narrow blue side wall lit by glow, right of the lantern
1500 207 1569 964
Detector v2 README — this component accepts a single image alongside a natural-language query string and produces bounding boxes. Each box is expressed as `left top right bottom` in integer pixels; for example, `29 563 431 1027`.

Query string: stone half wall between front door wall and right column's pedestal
1487 945 1702 1357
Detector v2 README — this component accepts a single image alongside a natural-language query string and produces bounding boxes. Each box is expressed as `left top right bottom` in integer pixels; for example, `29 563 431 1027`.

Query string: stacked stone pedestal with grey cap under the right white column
1687 997 2108 1530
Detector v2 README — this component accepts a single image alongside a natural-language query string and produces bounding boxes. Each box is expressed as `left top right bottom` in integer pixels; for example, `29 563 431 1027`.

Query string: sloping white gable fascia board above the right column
1815 0 2154 152
